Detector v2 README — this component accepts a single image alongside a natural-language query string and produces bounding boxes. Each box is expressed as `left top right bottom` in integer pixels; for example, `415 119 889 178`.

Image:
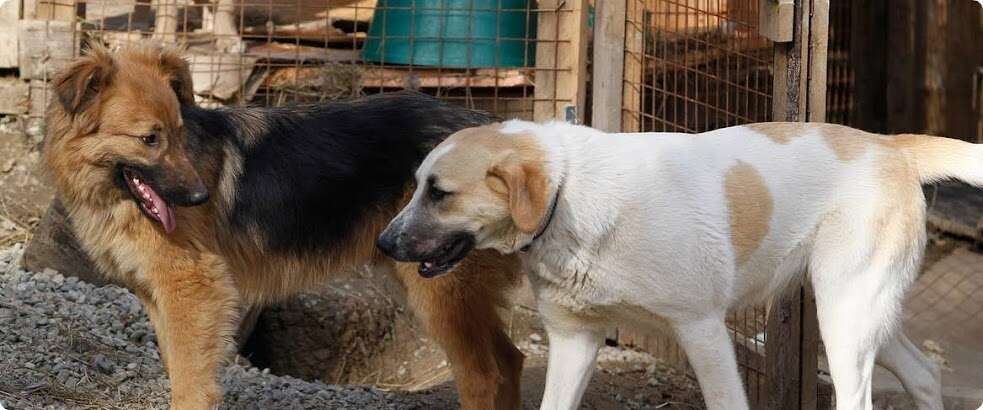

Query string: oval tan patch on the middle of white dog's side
724 161 774 266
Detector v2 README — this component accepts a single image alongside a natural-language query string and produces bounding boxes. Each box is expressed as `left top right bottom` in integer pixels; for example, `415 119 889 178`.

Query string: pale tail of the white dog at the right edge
895 135 983 187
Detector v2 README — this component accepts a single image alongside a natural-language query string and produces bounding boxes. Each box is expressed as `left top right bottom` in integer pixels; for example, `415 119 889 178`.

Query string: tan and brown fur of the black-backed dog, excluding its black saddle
44 44 522 410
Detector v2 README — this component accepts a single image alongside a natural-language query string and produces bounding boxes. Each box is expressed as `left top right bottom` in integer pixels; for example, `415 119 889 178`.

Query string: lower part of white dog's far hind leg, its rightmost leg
877 329 942 410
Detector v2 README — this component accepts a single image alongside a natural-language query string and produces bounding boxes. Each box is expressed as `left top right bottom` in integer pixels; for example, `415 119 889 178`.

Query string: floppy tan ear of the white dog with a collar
488 151 549 233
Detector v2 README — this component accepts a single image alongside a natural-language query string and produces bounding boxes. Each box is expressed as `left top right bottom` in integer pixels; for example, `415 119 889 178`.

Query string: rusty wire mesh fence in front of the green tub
26 0 588 119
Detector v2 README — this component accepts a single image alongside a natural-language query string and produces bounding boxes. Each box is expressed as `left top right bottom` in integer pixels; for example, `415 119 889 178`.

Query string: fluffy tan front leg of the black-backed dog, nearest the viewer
148 255 239 410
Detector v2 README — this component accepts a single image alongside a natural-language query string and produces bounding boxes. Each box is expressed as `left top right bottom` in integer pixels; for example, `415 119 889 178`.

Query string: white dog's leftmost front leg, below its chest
539 326 604 410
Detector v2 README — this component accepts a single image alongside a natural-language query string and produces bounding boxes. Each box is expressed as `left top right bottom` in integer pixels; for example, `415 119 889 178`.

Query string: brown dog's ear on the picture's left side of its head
52 47 116 117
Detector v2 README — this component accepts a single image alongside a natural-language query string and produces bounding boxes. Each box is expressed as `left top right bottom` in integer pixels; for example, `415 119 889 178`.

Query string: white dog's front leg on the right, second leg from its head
675 314 748 410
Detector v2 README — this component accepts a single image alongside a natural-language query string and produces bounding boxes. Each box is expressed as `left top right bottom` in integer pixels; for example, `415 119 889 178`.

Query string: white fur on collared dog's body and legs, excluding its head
479 121 960 409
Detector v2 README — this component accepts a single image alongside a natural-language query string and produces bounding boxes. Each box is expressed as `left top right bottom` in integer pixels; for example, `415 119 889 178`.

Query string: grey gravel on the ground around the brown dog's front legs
0 244 453 409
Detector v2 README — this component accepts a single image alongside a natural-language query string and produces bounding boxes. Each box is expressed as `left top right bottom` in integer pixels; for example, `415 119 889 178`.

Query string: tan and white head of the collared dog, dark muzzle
377 124 552 277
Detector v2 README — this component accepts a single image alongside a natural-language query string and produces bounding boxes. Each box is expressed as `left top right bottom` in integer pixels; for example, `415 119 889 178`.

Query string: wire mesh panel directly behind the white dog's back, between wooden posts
619 0 774 403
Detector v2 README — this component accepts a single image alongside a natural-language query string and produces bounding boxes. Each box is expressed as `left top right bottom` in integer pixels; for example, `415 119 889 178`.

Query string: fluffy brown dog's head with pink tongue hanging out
44 46 208 233
